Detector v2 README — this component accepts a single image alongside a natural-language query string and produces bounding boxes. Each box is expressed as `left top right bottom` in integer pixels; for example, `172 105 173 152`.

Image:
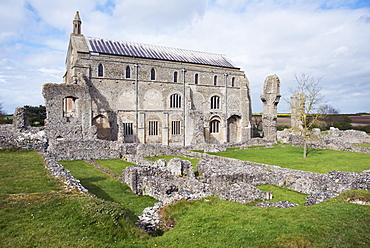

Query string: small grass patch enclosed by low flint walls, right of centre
257 184 307 206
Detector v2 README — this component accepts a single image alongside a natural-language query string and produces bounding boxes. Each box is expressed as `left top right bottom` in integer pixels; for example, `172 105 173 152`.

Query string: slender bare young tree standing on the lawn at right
289 72 325 158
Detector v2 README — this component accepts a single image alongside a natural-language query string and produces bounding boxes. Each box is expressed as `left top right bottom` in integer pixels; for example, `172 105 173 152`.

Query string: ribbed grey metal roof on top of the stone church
86 37 237 68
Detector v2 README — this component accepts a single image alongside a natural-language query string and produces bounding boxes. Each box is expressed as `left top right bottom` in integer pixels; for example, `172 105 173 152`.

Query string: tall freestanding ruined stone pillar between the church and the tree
261 74 281 140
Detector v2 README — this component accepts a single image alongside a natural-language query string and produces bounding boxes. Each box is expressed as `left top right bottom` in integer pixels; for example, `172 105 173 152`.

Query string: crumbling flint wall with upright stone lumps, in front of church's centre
120 158 266 204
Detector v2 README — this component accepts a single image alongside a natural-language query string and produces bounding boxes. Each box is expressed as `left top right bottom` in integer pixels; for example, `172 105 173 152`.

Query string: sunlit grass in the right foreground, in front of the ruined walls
147 192 370 247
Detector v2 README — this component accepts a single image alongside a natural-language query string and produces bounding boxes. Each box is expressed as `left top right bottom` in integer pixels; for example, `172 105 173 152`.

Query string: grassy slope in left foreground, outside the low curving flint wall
0 151 149 247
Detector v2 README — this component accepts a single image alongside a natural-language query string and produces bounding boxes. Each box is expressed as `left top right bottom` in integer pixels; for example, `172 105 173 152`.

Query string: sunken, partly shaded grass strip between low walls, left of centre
60 160 157 215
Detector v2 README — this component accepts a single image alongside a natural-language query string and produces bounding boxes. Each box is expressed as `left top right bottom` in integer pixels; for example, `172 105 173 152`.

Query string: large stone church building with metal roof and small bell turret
43 12 252 146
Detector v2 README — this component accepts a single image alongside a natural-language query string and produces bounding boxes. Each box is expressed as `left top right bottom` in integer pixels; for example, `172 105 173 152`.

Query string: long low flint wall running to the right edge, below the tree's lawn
197 158 370 194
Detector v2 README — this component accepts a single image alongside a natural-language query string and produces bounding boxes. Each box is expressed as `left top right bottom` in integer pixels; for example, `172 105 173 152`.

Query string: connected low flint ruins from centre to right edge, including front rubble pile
120 152 370 234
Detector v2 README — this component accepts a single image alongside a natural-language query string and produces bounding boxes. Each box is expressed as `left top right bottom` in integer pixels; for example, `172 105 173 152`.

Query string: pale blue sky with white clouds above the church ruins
0 0 370 113
